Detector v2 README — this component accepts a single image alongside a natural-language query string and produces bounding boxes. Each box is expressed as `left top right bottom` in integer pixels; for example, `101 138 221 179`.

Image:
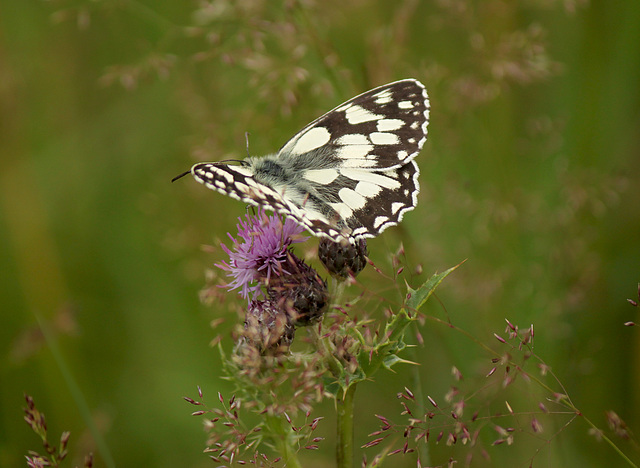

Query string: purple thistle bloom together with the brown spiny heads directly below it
216 210 329 354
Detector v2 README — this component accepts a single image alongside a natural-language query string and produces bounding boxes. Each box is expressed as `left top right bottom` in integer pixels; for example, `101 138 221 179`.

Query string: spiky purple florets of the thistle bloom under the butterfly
216 209 307 300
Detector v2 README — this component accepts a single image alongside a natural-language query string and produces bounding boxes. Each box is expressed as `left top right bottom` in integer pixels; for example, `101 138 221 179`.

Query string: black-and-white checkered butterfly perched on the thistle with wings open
174 79 430 243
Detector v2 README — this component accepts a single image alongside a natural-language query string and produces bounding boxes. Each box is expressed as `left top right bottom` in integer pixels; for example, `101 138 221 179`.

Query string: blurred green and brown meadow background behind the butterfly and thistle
0 0 640 467
